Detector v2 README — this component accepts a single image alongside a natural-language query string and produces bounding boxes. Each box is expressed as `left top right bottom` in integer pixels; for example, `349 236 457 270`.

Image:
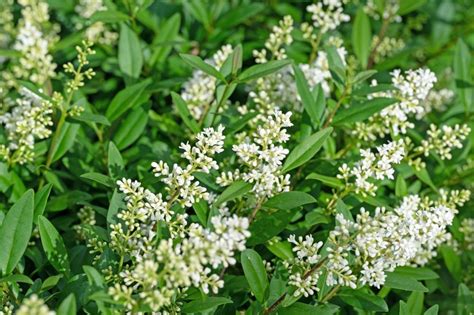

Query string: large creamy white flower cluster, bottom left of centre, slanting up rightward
109 215 250 311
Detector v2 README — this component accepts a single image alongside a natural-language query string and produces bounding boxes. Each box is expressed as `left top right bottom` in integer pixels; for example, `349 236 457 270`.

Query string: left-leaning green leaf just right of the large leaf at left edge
38 216 70 275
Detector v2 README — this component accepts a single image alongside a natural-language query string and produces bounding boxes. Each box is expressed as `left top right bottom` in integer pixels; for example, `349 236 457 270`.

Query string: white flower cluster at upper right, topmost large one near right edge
353 69 437 141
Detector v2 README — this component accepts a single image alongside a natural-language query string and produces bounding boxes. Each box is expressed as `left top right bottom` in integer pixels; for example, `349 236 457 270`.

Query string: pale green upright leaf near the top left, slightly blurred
118 23 143 79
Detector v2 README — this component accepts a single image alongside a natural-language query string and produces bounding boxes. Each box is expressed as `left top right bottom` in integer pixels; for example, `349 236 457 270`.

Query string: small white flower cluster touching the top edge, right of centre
306 0 350 33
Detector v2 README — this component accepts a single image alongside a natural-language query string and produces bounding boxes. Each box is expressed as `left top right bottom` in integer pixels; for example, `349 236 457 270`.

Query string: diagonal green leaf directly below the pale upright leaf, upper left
105 79 151 121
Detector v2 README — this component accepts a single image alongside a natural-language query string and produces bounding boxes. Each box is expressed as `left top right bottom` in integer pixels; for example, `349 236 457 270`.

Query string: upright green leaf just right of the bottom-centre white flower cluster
240 248 268 303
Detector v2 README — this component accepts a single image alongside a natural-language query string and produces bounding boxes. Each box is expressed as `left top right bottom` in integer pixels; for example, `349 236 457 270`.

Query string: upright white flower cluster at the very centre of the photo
217 109 293 200
